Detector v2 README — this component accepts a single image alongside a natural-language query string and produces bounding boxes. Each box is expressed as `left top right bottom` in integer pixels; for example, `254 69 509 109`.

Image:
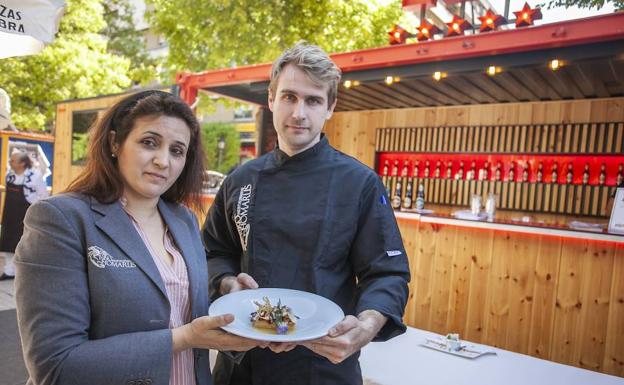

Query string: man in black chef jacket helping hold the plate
204 43 409 385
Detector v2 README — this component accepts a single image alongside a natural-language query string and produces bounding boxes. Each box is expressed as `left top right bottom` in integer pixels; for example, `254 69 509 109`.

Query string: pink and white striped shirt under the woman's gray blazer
121 199 195 385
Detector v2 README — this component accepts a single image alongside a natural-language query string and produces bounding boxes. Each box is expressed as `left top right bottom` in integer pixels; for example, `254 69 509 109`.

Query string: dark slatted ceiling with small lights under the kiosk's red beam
205 40 624 111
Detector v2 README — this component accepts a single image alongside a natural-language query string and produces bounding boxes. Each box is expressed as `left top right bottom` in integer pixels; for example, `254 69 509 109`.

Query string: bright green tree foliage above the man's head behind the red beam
148 0 402 73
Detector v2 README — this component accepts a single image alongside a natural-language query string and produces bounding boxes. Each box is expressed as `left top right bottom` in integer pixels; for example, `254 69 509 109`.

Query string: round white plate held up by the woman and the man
208 288 344 342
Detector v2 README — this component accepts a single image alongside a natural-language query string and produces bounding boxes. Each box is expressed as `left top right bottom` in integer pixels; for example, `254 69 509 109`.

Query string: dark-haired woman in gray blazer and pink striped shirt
16 91 260 385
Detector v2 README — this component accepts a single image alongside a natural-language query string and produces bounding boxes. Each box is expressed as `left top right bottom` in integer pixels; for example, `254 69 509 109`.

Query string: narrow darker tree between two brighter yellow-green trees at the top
102 0 158 84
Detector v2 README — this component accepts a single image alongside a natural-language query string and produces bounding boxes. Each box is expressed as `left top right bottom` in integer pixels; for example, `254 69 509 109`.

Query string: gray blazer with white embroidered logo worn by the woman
15 194 212 385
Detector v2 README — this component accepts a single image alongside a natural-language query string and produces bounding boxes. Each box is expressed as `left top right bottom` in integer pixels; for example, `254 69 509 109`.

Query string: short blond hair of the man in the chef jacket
269 41 341 108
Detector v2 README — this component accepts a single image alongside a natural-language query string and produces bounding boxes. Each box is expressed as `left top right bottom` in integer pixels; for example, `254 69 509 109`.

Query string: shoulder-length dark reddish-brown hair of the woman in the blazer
66 90 205 211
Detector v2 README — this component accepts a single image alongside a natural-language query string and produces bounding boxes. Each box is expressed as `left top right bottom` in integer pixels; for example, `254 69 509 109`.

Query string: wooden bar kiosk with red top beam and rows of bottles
178 12 624 376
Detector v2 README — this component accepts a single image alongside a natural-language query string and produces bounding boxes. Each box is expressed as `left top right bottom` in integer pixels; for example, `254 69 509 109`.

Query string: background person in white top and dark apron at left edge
0 151 48 281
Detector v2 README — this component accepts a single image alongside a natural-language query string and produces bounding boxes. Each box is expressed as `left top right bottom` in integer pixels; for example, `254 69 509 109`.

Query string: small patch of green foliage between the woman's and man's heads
201 123 240 174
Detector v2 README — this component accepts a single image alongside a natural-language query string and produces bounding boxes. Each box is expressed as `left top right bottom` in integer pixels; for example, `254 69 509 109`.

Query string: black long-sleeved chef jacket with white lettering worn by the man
203 136 410 385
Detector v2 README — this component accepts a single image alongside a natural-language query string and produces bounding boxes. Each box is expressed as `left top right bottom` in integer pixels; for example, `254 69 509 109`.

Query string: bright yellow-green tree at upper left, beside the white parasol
0 0 130 129
